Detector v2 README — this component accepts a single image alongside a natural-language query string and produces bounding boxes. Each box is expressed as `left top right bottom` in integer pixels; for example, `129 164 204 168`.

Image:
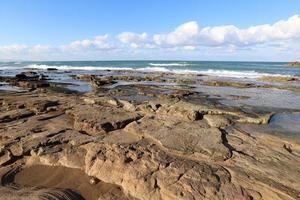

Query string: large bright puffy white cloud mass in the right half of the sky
153 15 300 48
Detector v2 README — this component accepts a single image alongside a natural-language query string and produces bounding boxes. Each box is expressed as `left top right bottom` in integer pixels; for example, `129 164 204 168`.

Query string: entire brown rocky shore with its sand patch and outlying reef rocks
0 73 300 200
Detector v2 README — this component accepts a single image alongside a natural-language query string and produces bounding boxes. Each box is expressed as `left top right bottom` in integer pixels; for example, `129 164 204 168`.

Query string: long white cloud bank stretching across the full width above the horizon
0 15 300 58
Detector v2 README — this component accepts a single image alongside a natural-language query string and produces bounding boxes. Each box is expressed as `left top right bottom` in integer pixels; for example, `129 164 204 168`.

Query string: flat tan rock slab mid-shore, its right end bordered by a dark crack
125 117 231 160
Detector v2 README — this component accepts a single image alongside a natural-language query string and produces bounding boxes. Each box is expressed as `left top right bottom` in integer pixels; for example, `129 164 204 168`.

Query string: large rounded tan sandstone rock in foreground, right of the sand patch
78 141 250 200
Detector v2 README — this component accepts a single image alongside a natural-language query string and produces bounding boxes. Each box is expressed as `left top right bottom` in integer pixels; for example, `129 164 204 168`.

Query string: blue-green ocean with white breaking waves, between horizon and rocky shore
0 61 300 79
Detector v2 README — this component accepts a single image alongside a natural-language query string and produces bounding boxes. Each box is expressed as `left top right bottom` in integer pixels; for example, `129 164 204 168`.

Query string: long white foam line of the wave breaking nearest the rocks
23 64 289 79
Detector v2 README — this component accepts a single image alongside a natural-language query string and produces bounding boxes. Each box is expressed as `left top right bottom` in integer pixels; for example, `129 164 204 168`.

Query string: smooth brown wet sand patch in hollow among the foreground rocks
14 165 122 200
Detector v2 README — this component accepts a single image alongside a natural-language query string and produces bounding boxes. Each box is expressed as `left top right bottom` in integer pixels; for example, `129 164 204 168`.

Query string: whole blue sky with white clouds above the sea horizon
0 0 300 61
